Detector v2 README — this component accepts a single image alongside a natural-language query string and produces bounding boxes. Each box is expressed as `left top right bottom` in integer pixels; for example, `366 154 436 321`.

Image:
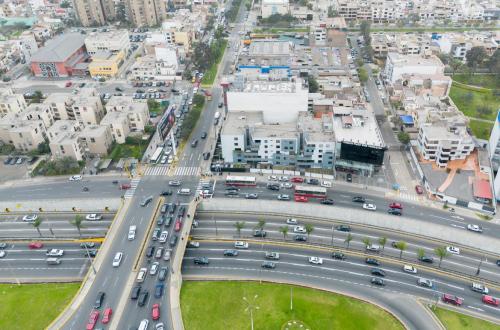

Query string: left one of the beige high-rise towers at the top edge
73 0 116 26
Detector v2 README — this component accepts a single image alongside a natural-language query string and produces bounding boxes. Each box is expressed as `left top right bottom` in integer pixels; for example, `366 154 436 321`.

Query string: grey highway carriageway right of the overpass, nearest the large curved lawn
183 241 498 329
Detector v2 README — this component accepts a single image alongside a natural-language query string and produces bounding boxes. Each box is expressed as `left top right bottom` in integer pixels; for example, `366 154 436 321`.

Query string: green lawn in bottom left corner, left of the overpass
0 283 80 330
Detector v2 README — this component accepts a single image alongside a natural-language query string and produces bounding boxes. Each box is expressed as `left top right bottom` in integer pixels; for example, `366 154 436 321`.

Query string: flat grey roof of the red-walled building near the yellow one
31 33 85 62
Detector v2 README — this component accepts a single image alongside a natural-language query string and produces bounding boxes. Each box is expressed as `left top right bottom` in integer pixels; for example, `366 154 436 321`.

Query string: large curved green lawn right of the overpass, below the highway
181 281 403 330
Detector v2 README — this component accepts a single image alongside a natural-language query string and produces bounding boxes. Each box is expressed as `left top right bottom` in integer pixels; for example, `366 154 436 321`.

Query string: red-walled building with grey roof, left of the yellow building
31 33 88 78
